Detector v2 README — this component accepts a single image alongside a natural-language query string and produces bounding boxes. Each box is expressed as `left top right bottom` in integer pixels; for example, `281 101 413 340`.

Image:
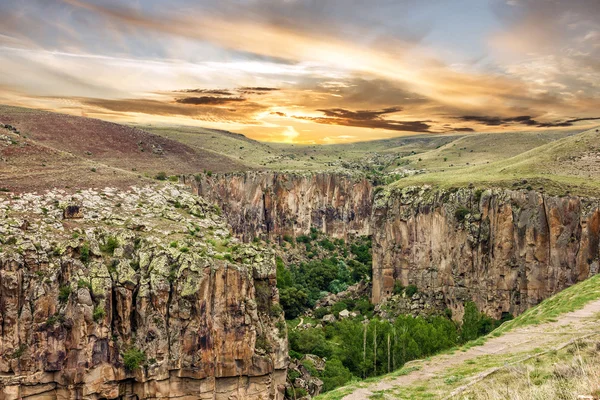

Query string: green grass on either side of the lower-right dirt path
318 275 600 400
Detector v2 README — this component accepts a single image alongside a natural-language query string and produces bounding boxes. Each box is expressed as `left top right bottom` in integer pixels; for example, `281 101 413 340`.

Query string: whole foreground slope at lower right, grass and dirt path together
319 275 600 400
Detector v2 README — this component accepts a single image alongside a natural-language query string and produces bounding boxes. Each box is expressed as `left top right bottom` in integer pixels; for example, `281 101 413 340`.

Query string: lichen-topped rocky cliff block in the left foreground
0 185 288 399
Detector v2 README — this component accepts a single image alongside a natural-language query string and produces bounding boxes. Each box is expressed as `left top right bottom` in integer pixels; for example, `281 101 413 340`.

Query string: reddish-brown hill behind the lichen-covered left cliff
0 106 248 190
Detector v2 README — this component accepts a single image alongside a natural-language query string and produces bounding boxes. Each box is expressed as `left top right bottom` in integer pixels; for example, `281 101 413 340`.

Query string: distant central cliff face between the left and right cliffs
186 172 373 241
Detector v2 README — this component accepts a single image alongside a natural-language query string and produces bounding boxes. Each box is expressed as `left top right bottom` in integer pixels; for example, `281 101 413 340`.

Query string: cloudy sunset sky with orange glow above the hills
0 0 600 144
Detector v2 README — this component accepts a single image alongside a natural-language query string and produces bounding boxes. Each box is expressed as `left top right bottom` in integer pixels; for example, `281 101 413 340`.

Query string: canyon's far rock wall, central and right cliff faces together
193 172 600 319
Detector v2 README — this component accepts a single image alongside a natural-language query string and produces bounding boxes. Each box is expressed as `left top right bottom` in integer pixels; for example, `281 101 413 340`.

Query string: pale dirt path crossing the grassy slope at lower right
343 300 600 400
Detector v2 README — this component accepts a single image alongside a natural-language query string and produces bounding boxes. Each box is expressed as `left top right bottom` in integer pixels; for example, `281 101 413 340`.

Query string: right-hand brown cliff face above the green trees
372 188 600 317
